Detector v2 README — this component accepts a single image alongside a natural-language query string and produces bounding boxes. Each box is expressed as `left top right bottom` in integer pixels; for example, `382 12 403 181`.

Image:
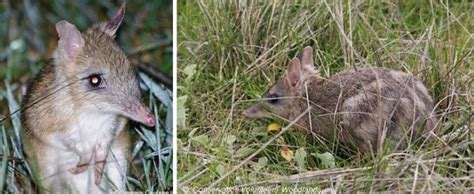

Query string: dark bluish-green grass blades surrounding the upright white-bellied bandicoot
0 0 173 193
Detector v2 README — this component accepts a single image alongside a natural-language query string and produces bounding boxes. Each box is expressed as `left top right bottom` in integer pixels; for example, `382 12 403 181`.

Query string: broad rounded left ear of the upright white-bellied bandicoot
56 20 84 60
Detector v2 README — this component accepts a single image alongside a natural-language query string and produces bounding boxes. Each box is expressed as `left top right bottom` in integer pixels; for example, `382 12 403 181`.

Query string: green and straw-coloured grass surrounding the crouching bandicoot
177 0 474 193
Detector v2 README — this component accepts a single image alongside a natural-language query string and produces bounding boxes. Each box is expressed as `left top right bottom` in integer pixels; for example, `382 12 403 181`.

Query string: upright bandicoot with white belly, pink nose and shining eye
21 3 154 193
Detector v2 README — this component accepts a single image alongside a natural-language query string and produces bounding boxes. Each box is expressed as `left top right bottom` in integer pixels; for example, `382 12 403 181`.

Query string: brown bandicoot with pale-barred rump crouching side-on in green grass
244 47 435 152
